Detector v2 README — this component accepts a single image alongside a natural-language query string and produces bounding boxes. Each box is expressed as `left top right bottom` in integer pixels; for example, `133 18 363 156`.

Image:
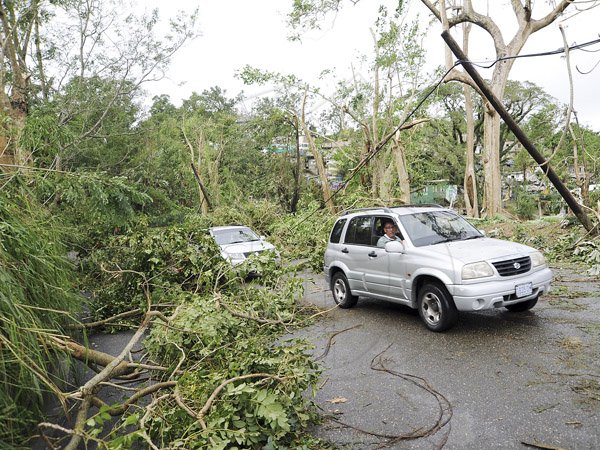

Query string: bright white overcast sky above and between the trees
144 0 600 131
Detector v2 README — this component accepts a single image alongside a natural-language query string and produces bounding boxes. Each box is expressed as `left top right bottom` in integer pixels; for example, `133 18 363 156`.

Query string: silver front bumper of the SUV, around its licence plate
447 267 552 311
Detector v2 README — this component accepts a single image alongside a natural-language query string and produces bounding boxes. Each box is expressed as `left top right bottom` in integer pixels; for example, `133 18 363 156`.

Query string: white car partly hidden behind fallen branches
208 226 277 266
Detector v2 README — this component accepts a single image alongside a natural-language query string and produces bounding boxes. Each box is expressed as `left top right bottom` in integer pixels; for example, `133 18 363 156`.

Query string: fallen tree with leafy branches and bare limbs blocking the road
32 222 318 449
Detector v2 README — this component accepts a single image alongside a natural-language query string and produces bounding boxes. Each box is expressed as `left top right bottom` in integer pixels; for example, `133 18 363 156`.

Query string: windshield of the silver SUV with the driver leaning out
400 211 483 247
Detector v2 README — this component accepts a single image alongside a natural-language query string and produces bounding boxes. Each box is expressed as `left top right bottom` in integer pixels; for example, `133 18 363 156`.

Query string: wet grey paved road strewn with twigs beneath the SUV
298 268 600 450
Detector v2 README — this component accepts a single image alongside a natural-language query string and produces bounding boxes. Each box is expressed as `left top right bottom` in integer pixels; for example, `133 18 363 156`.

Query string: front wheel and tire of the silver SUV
417 281 458 331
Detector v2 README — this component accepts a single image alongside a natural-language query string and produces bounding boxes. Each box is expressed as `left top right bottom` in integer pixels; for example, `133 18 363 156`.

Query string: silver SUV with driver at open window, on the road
324 205 552 331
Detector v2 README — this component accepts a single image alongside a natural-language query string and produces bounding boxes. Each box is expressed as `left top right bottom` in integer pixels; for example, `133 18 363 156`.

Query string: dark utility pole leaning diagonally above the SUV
442 31 594 233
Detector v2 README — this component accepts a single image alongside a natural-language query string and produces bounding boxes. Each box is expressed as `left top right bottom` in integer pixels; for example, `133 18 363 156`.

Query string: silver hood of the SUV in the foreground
421 238 536 264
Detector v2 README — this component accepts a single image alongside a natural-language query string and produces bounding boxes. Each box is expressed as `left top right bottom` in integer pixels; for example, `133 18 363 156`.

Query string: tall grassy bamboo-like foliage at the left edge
0 191 81 448
